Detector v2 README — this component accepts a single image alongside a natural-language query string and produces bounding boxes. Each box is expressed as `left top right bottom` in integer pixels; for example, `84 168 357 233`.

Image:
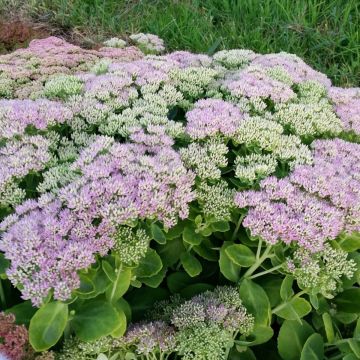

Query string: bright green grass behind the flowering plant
0 0 360 86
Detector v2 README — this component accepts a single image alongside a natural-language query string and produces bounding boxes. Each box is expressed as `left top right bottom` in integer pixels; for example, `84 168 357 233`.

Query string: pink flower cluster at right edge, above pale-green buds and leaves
235 139 360 252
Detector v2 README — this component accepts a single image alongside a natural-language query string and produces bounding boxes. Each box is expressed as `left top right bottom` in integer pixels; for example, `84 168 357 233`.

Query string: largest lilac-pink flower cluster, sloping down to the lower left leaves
0 137 194 305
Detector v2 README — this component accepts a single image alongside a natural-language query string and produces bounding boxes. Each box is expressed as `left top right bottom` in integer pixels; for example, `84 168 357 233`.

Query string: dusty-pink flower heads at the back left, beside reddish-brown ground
0 37 143 99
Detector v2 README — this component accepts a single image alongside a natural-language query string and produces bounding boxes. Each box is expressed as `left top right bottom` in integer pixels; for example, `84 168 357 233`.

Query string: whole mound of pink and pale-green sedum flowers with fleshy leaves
0 34 360 360
